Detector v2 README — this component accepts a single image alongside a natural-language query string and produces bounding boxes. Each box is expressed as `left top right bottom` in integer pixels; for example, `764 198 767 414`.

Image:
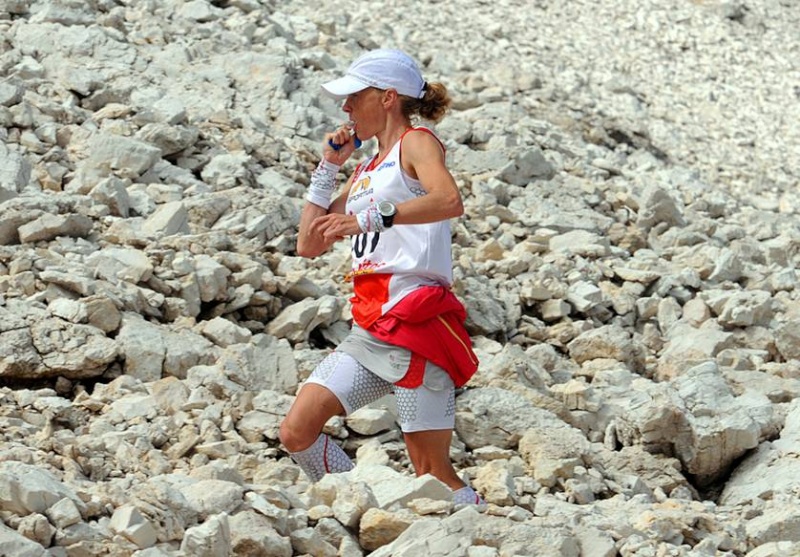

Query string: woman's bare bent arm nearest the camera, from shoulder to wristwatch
390 131 464 224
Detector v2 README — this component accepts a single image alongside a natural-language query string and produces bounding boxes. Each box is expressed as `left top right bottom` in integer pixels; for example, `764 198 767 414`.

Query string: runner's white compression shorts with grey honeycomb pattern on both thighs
306 351 456 433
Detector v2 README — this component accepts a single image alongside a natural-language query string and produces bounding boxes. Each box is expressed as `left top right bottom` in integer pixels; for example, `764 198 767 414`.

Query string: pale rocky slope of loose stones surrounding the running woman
0 0 800 557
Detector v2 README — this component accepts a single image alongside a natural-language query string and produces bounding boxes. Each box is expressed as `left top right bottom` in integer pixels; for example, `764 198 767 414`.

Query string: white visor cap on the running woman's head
322 48 425 99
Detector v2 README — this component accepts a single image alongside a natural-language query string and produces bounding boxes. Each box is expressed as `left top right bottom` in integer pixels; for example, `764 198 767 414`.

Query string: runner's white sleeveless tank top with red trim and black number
345 127 453 322
